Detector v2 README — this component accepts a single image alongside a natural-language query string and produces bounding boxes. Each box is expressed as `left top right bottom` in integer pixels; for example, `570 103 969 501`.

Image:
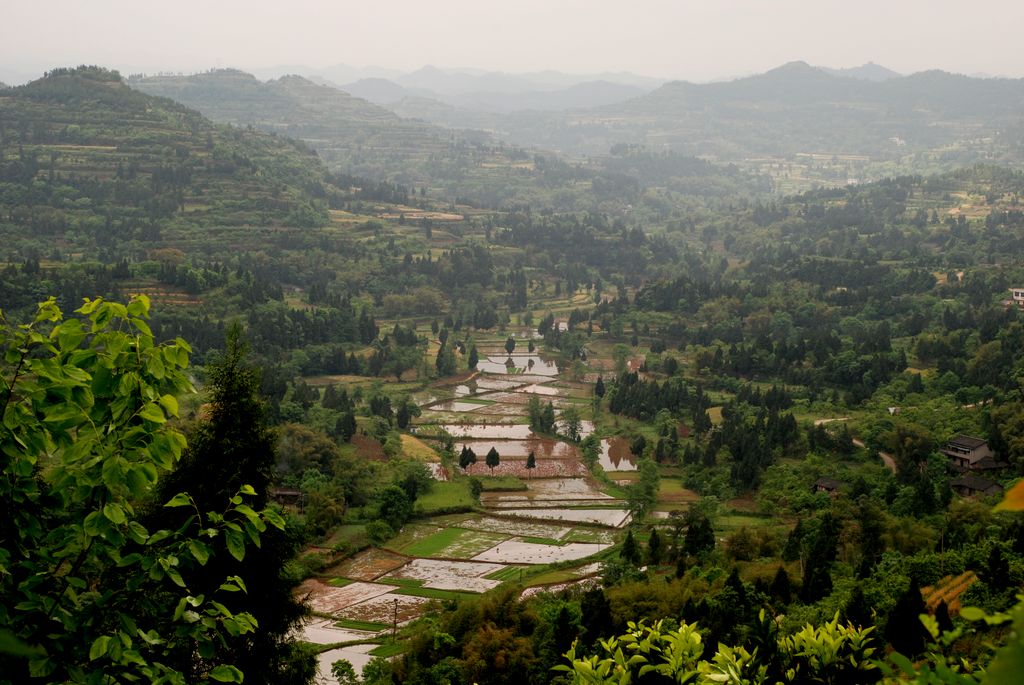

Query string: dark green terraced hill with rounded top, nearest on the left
0 67 344 251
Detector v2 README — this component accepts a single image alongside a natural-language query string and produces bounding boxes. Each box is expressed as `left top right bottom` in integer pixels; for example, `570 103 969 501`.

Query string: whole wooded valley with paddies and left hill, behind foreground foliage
6 65 1024 683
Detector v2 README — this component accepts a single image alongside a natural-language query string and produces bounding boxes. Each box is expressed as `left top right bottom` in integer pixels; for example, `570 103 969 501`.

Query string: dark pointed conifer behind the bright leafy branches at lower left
150 329 311 683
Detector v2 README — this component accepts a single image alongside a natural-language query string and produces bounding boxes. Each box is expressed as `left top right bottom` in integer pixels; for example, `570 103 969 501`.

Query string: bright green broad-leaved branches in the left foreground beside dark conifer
0 296 284 683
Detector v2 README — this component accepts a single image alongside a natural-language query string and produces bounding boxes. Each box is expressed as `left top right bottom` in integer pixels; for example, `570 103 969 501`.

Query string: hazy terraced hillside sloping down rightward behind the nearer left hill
130 70 770 211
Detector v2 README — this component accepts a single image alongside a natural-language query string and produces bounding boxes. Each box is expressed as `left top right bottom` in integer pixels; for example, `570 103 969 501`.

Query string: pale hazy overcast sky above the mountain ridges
0 0 1024 80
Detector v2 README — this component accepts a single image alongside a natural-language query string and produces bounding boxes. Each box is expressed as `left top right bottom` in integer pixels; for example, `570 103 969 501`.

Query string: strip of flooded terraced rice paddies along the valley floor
302 335 635 651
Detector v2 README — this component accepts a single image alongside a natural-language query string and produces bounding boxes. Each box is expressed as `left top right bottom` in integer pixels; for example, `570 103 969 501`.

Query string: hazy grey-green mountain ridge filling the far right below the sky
389 62 1024 191
